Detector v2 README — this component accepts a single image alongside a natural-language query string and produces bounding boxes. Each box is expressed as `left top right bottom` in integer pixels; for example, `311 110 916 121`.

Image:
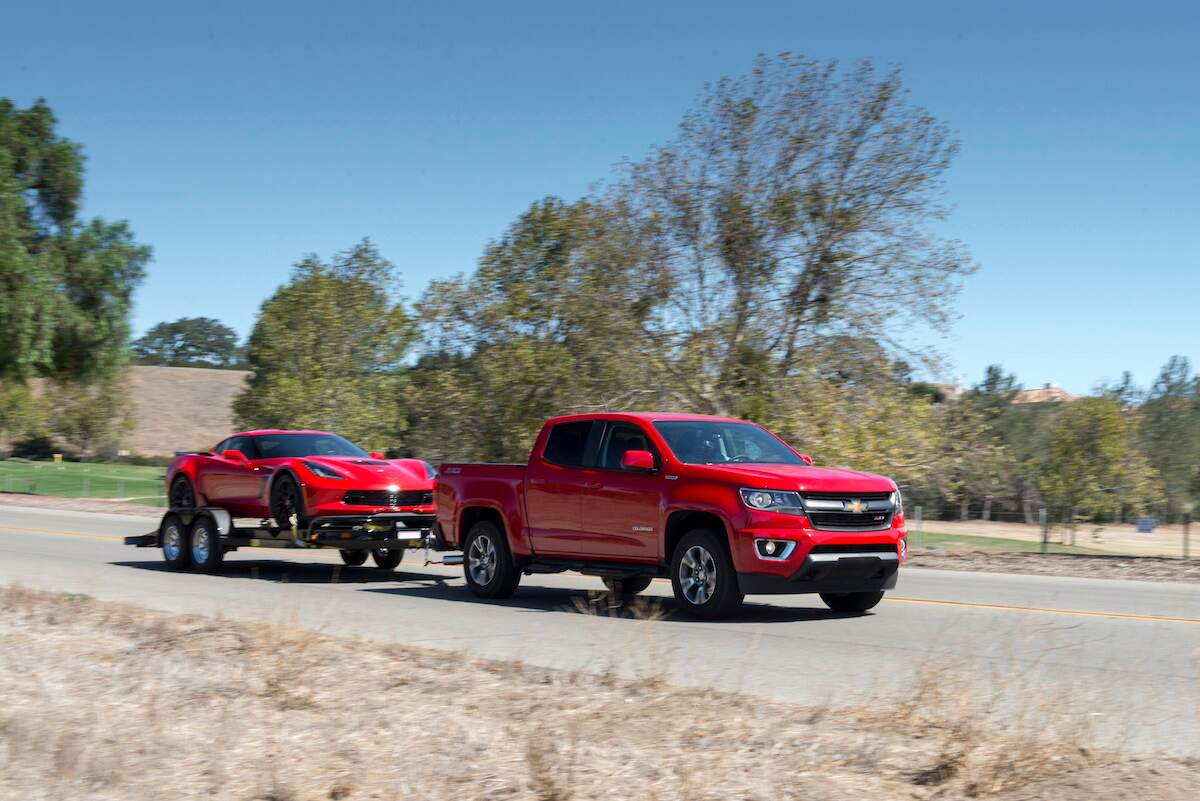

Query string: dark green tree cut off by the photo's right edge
1140 356 1200 513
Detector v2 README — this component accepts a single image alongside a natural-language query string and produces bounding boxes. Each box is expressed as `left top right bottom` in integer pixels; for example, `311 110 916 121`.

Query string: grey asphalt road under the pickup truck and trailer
0 506 1200 755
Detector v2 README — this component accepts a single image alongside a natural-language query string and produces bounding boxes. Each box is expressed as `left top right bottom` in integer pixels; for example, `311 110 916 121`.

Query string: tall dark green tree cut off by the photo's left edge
0 98 150 381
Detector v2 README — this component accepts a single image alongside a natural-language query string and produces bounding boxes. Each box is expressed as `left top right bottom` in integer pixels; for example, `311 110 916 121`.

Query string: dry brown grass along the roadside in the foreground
0 588 1200 801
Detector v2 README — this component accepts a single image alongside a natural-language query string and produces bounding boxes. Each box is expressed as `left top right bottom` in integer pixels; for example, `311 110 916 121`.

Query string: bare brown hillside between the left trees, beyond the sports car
125 366 250 456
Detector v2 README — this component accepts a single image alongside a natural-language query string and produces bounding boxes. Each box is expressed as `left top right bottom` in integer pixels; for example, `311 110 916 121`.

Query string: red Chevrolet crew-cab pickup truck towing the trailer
434 414 906 618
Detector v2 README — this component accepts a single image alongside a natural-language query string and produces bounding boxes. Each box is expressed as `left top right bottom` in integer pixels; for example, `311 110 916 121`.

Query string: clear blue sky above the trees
0 0 1200 392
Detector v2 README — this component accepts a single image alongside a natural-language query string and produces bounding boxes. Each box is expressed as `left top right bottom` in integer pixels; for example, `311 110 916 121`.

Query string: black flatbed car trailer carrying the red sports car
125 507 462 573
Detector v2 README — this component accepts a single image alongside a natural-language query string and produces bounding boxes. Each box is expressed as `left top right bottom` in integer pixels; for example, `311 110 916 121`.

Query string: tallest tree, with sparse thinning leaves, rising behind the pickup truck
608 53 973 414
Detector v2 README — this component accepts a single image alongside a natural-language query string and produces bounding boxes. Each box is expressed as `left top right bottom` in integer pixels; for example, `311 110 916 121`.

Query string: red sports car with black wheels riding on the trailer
167 430 436 529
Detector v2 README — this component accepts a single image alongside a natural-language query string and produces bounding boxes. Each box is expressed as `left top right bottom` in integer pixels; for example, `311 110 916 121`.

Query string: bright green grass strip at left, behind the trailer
0 459 166 506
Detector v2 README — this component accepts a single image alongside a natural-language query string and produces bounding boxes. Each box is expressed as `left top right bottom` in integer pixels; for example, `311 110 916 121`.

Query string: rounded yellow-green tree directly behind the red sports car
234 240 415 450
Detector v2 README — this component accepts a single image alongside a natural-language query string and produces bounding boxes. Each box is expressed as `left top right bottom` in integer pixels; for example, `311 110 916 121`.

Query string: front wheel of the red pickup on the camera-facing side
671 529 745 620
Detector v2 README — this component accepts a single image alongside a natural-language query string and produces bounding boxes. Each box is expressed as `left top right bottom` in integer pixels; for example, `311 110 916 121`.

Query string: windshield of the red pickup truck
654 420 805 464
